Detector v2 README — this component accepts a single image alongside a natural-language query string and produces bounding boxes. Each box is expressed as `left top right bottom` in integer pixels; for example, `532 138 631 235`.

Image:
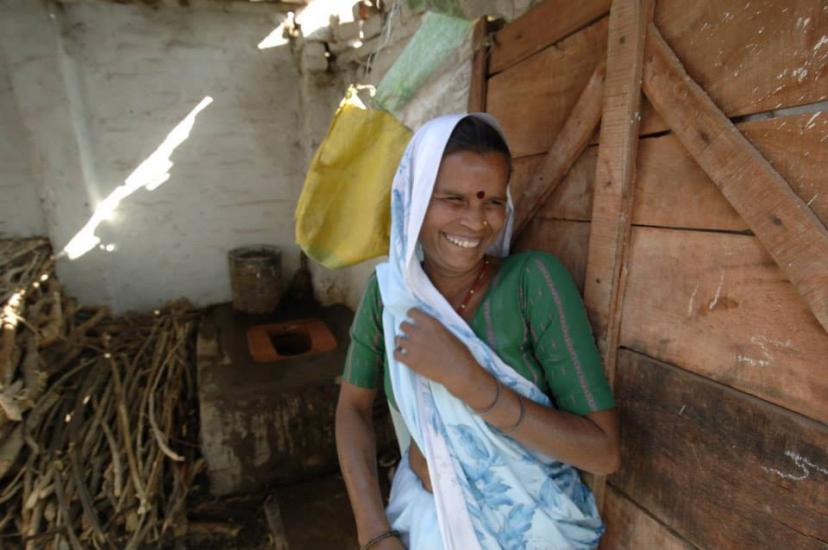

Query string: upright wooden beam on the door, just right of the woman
584 0 653 508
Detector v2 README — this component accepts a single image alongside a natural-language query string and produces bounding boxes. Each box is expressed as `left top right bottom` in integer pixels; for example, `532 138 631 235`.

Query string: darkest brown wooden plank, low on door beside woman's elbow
610 350 828 550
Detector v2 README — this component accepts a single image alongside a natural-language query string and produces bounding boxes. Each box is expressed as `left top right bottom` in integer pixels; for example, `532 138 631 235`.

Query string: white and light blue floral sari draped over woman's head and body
377 113 603 550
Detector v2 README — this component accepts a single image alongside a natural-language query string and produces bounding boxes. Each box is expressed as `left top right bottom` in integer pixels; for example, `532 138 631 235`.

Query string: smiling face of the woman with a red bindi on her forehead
420 151 509 273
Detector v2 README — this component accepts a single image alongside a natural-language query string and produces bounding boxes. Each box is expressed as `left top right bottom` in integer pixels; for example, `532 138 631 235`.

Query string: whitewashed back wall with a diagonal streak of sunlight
1 0 306 311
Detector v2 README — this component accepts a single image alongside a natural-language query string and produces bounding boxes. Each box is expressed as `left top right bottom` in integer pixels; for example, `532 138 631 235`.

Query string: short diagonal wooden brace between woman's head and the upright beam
512 62 604 240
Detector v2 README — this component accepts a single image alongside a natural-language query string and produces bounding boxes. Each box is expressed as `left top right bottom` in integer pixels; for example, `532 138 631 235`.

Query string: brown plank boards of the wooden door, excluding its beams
486 0 828 549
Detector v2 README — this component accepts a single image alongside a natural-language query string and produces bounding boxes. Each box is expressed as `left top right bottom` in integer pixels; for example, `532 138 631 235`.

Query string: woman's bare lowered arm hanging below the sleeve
336 381 402 550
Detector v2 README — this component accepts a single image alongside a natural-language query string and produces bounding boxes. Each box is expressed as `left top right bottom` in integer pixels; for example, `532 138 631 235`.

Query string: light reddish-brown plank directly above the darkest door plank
616 226 828 423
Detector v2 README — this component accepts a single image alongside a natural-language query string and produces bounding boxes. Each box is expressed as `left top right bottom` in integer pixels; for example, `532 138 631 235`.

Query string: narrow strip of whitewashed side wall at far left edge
0 31 46 237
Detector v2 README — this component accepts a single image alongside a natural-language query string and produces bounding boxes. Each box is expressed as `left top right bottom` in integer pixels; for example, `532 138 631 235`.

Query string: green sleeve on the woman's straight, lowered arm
342 274 385 389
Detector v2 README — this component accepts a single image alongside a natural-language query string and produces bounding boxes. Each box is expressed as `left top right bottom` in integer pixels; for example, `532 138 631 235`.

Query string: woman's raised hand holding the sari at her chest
394 308 477 391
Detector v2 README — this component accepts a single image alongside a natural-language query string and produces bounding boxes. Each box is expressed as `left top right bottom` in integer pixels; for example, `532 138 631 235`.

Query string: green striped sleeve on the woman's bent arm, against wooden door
522 252 615 415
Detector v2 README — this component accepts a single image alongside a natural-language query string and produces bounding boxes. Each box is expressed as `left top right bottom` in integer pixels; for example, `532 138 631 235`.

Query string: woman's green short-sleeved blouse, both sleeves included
342 251 615 415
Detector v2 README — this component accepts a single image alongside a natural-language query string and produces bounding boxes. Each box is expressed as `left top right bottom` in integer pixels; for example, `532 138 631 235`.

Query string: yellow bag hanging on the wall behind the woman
296 87 411 269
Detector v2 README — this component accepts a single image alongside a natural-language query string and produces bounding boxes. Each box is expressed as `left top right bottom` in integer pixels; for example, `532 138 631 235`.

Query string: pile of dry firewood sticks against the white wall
0 239 203 550
